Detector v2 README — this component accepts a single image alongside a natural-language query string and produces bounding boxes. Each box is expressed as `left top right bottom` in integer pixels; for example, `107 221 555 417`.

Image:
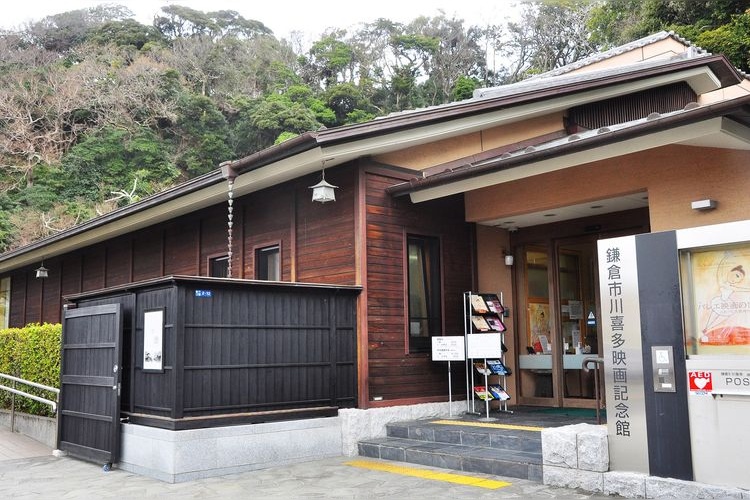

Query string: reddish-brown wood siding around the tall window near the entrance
366 173 473 400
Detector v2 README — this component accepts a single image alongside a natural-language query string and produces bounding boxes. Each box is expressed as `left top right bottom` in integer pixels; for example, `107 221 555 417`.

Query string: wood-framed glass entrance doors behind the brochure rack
517 237 600 407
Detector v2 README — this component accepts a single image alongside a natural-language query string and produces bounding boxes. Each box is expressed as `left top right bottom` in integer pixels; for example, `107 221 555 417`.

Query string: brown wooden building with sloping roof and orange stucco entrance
0 29 750 422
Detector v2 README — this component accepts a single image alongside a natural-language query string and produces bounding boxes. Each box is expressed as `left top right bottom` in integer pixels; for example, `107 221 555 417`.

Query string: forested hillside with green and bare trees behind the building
0 0 750 251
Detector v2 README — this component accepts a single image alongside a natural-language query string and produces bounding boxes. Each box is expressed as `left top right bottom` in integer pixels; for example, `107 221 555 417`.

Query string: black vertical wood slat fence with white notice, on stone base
69 277 359 428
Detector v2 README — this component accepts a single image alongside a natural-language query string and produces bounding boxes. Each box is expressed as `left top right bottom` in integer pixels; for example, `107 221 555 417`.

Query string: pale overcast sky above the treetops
0 0 523 38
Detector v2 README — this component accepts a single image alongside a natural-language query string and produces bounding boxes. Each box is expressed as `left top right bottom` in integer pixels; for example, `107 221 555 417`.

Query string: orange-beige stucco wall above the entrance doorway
465 146 750 231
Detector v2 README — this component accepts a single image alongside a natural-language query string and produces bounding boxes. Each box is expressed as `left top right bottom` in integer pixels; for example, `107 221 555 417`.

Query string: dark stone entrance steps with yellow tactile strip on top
359 420 542 482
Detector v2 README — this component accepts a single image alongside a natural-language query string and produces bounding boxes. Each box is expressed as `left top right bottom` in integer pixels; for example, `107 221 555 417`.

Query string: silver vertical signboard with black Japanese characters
598 236 649 473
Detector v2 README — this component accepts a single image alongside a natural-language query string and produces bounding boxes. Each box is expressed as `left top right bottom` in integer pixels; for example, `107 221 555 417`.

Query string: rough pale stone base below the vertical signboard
542 424 750 499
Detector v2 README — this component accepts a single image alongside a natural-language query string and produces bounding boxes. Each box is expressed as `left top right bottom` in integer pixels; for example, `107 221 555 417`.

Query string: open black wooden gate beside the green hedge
57 304 122 470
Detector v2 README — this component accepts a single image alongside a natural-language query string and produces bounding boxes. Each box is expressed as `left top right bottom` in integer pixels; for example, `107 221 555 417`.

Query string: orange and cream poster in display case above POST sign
688 247 750 354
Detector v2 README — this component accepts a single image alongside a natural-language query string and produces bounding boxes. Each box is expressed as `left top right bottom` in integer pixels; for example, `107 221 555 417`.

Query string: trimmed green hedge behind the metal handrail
0 323 62 416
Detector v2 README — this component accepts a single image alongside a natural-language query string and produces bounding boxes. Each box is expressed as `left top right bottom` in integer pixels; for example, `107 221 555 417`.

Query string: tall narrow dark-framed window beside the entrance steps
407 236 442 351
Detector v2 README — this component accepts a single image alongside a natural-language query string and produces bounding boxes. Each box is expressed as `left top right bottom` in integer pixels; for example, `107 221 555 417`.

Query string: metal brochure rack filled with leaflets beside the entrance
464 292 512 420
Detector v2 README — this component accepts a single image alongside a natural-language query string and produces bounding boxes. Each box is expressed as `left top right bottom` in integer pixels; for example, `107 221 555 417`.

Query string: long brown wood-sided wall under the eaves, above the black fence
5 165 356 326
